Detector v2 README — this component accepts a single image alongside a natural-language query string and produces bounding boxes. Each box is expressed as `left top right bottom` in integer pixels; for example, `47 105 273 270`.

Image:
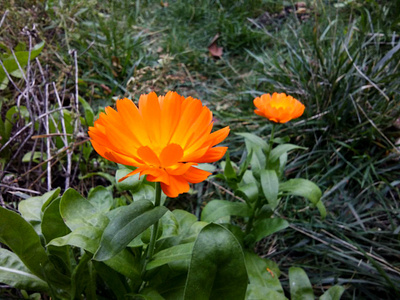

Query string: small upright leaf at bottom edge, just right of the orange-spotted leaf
289 267 314 300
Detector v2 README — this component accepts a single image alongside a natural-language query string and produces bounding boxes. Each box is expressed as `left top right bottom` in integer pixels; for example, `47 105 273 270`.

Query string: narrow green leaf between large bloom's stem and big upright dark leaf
146 243 194 270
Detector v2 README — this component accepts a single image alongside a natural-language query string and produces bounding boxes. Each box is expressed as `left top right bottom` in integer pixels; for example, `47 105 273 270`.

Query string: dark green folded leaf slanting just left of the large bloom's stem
94 200 168 261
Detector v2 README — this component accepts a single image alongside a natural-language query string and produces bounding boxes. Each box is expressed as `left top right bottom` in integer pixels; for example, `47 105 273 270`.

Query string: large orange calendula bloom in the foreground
89 92 229 197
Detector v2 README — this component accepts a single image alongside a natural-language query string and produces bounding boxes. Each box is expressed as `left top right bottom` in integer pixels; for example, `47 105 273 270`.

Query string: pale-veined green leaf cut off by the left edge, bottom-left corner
0 248 49 291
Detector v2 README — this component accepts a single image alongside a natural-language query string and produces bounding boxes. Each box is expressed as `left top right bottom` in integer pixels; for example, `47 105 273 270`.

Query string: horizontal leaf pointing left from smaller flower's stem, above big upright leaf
201 200 251 222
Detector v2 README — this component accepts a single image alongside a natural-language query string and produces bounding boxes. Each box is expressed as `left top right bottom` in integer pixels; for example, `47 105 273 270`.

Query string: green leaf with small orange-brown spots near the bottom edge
244 251 286 299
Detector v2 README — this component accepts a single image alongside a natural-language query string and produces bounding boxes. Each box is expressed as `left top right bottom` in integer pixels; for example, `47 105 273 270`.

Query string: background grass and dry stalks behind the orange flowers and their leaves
0 0 400 299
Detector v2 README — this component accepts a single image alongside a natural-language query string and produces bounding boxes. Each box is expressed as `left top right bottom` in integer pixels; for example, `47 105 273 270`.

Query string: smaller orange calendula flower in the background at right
253 93 305 123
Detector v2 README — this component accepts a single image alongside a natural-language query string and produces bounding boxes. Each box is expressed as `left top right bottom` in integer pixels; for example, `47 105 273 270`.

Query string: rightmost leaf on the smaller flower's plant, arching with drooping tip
279 178 326 218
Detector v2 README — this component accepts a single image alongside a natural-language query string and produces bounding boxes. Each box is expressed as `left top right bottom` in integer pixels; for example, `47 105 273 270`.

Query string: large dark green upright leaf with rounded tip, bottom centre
184 224 248 300
